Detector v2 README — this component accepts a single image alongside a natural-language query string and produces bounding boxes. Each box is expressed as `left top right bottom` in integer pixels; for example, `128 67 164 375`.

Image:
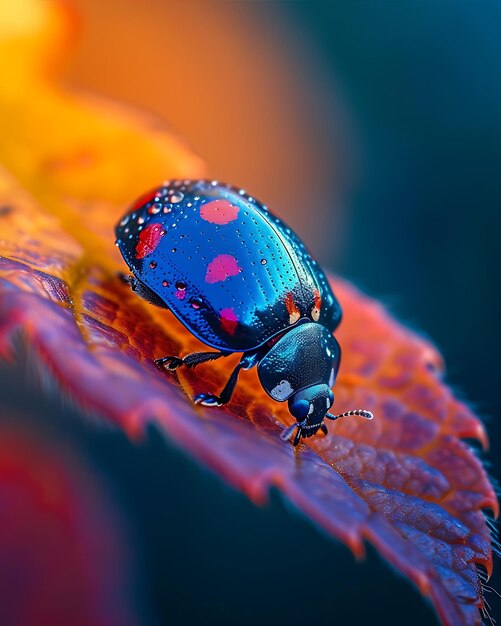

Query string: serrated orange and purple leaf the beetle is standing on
0 0 498 625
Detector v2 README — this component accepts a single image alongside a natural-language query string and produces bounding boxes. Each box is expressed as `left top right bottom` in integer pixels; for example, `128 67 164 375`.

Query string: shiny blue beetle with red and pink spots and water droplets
115 180 373 446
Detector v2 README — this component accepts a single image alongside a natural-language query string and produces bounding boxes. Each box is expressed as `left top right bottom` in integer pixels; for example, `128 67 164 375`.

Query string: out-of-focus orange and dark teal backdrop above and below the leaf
0 0 501 625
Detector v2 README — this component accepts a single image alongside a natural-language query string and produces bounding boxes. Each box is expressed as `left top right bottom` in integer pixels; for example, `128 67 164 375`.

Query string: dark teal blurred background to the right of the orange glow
281 0 501 623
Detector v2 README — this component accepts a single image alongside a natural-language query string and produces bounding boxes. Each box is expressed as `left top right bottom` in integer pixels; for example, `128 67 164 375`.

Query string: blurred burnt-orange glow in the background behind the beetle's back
66 0 347 258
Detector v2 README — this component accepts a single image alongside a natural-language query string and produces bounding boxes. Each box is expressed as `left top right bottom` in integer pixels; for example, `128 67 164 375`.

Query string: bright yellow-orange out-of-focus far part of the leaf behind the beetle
0 0 204 248
